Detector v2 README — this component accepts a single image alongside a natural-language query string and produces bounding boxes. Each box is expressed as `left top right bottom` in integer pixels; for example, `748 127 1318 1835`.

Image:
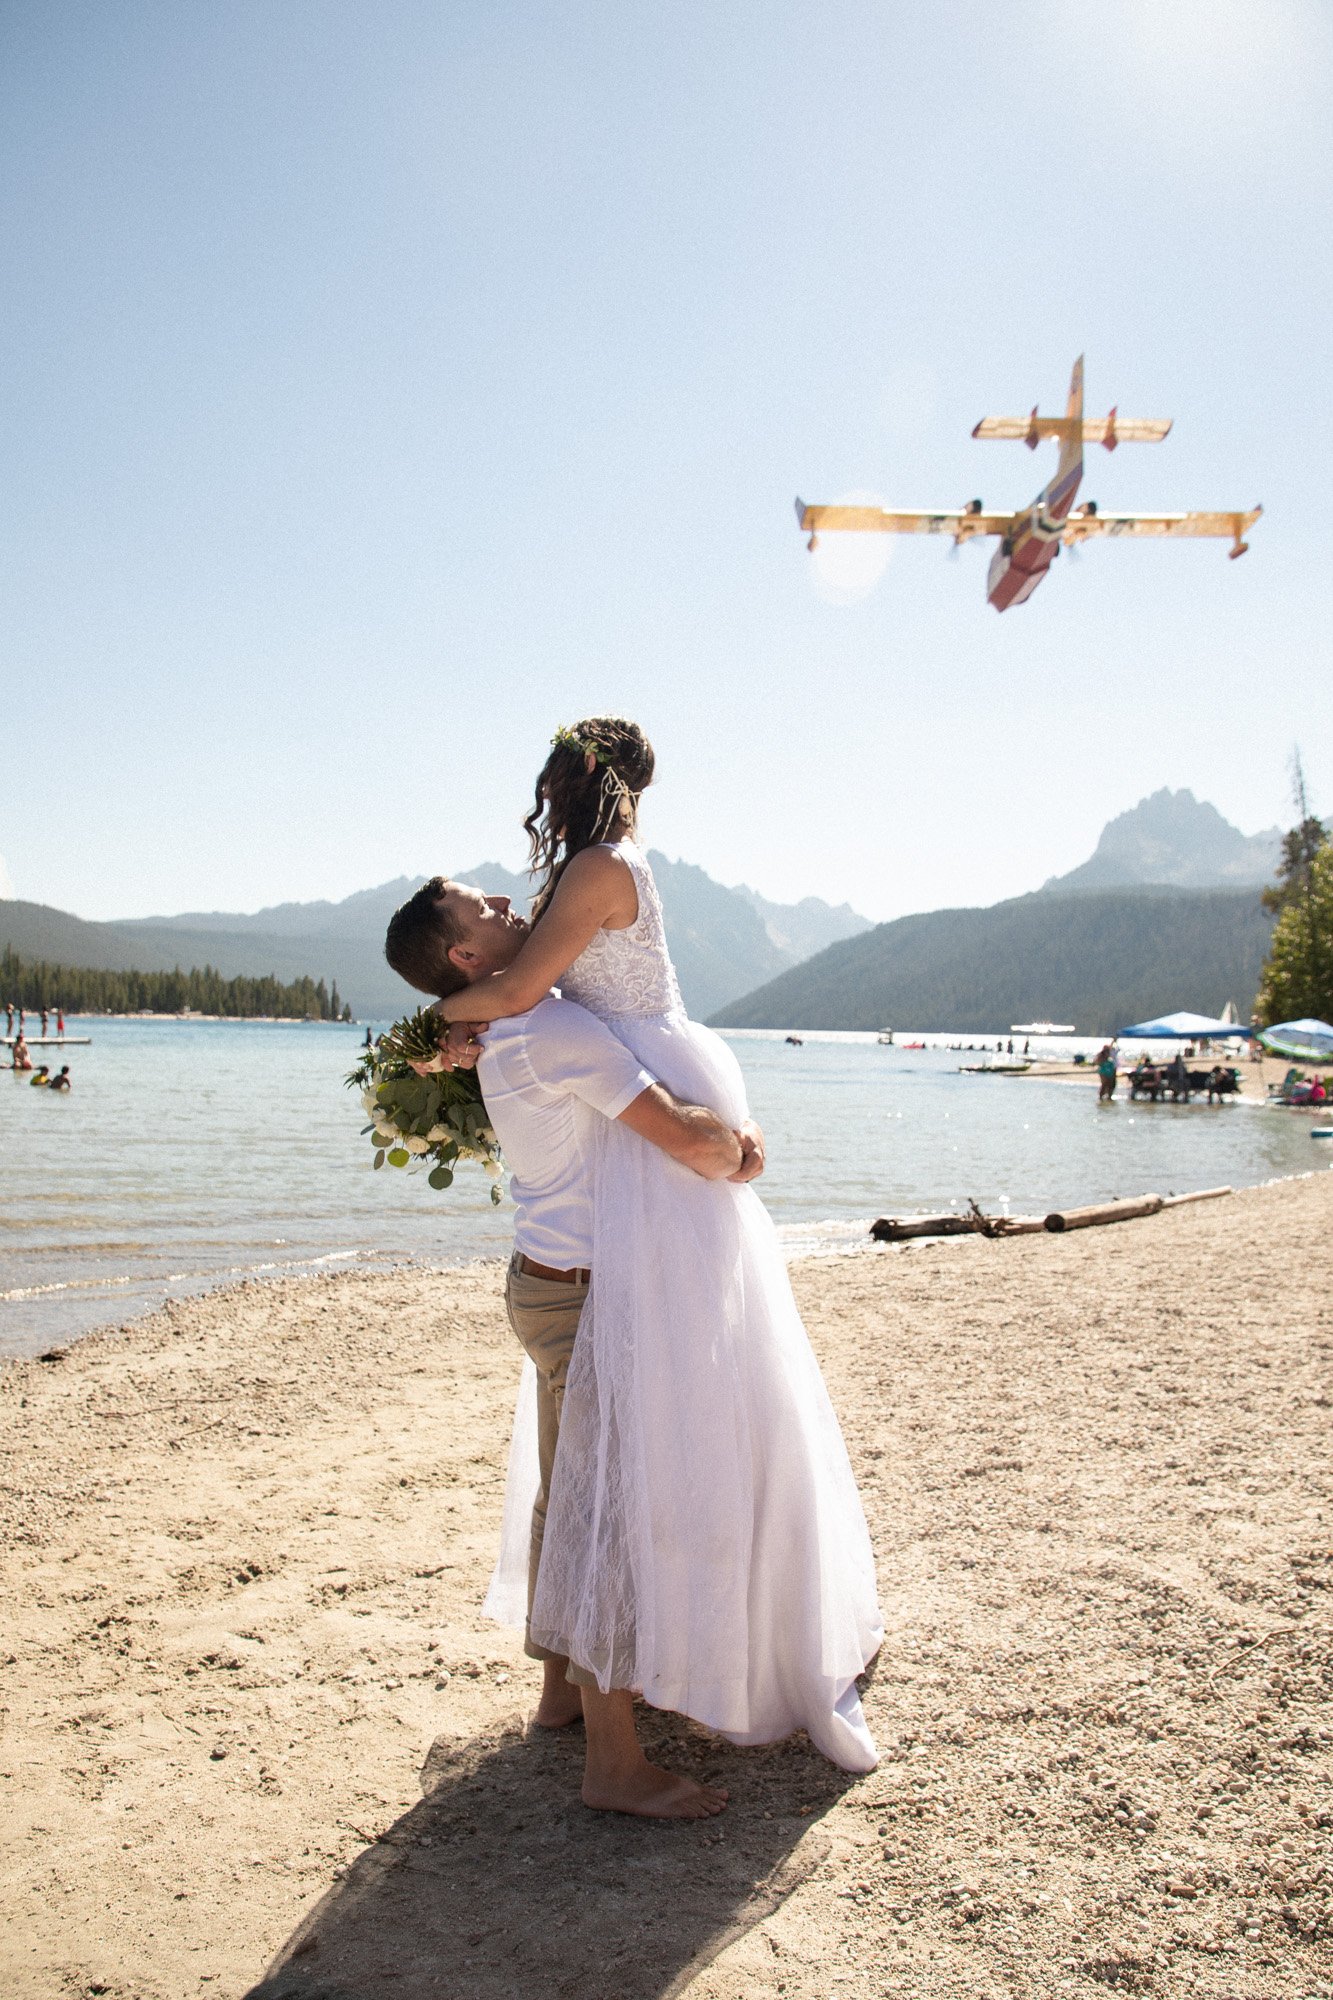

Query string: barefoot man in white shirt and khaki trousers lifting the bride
384 876 765 1820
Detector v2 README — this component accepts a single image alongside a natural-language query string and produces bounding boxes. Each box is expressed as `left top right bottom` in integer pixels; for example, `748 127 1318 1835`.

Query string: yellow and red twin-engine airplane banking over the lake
797 356 1263 612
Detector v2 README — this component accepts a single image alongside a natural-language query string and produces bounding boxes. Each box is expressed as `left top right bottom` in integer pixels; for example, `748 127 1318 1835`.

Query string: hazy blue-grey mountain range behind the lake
0 790 1281 1034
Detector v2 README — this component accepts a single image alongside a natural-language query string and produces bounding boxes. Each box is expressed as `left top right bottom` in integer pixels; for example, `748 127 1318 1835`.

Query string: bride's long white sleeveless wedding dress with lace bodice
486 840 883 1770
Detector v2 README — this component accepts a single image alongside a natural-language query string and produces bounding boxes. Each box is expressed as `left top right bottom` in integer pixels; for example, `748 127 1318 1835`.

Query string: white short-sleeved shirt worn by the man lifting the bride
476 994 656 1270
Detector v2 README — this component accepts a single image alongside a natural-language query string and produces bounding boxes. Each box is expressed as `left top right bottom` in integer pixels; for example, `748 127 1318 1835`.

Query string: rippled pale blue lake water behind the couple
0 1020 1327 1354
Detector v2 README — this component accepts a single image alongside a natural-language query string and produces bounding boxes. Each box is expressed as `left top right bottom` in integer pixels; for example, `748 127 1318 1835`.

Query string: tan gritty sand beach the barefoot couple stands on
0 1172 1333 2000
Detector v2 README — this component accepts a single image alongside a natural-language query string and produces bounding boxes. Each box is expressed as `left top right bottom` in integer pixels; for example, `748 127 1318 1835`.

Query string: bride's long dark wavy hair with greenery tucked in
522 716 652 916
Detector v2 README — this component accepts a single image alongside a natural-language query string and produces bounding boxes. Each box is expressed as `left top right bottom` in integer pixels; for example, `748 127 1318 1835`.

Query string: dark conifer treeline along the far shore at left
0 946 352 1020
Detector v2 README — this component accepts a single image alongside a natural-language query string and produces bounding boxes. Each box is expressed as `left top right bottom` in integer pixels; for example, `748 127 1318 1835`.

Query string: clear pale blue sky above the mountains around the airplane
0 0 1333 916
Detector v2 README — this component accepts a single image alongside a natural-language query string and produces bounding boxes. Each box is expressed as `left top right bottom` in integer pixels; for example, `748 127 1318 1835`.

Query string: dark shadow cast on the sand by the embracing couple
246 1710 853 2000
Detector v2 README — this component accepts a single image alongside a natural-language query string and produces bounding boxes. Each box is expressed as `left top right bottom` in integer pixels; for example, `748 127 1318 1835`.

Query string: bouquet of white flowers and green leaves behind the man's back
346 1008 500 1202
